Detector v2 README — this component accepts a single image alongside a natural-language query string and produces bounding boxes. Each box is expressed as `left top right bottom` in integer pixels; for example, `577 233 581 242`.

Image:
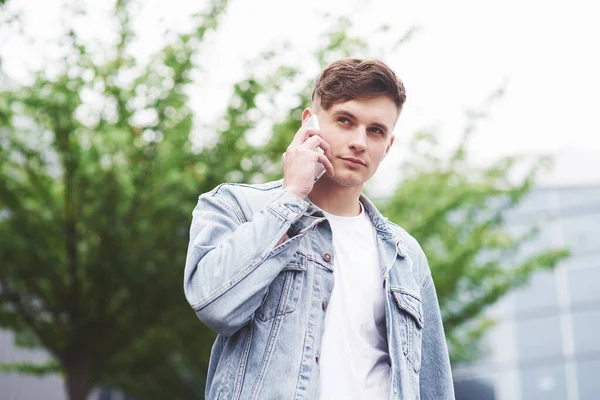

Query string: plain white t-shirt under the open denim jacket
319 205 391 400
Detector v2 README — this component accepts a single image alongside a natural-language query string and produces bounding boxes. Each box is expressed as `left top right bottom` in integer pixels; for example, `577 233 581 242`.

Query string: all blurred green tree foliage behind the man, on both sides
0 0 564 400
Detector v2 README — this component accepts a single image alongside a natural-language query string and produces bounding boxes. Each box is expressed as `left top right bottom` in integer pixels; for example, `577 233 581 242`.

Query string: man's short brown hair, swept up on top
312 58 406 110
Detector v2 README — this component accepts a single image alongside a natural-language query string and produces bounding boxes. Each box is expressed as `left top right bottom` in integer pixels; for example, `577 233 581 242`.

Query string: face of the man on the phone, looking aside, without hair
302 97 399 187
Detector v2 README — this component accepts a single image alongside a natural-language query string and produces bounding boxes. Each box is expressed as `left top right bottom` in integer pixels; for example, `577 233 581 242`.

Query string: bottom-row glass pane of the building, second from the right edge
521 364 567 400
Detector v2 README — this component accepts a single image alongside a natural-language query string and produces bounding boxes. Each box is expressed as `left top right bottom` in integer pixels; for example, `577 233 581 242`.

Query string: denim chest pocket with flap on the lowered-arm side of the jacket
392 288 424 372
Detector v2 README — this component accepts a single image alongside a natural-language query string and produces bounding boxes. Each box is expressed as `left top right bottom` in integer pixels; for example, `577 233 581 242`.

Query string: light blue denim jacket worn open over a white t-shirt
184 181 454 400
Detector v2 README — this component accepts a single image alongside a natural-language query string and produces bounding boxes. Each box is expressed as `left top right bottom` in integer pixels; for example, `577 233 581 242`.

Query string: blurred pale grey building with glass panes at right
454 186 600 400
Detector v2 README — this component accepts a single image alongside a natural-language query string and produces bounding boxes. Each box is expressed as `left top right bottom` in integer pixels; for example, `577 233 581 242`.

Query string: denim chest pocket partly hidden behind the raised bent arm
254 253 306 322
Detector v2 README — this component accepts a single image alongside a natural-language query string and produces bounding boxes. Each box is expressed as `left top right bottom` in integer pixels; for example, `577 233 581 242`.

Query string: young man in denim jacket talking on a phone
184 59 454 400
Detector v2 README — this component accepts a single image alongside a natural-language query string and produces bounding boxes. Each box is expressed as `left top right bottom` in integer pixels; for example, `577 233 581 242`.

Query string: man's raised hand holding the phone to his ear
281 127 333 199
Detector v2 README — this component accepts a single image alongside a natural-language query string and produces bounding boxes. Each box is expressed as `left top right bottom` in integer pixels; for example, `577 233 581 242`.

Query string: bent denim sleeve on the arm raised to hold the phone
184 188 308 336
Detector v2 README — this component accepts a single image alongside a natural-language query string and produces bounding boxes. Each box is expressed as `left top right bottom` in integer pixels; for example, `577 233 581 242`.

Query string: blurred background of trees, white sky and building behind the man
0 0 600 400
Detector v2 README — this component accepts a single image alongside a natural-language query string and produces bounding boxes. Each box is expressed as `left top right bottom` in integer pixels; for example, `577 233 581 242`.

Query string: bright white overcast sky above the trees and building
0 0 600 192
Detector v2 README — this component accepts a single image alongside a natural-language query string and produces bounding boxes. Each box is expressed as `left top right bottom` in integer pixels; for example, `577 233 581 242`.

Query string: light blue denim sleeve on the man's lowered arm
419 273 455 400
